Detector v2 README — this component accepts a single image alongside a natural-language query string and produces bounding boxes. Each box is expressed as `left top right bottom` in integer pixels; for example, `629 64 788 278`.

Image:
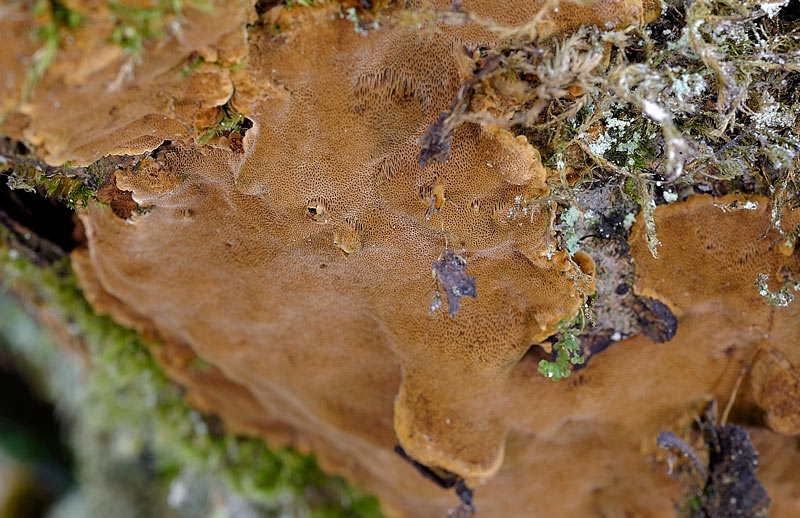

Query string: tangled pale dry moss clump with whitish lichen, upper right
423 0 800 262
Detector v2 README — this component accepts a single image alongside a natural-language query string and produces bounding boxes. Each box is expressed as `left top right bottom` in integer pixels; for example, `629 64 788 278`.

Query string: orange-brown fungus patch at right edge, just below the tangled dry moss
631 196 800 320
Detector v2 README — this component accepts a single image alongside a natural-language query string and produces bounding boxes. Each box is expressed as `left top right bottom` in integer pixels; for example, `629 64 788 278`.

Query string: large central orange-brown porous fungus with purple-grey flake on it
70 2 585 488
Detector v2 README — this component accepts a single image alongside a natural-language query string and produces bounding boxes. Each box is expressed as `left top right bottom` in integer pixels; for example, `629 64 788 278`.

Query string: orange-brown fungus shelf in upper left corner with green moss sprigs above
0 0 252 165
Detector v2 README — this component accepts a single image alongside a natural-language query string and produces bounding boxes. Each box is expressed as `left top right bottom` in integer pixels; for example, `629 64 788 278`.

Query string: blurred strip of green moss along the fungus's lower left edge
0 234 381 518
